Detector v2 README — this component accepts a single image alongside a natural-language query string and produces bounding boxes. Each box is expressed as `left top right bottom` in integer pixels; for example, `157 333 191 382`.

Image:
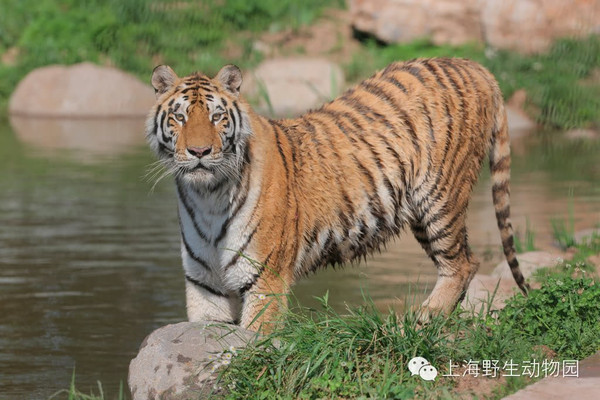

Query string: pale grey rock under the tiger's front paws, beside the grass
129 322 256 400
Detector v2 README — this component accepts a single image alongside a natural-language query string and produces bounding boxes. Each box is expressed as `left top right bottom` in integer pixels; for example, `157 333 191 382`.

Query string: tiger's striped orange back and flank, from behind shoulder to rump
284 59 502 271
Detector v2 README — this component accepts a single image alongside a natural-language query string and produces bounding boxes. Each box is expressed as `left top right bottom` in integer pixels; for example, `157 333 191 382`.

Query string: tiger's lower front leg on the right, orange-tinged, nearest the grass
240 270 291 333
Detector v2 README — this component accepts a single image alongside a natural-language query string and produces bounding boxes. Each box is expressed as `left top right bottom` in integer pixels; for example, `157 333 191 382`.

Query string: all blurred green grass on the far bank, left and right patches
0 0 600 129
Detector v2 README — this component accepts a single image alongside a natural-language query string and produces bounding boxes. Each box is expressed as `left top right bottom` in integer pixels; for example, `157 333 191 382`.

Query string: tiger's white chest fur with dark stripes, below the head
178 178 260 293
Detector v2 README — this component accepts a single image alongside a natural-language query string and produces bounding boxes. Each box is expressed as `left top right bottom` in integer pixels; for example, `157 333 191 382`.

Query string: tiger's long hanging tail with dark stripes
489 99 530 295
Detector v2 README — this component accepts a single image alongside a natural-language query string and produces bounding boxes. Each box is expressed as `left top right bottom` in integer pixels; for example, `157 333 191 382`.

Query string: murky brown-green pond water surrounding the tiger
0 120 600 399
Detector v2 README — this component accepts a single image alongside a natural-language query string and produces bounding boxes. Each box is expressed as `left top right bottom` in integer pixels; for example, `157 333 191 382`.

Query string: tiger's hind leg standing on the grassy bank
411 203 479 322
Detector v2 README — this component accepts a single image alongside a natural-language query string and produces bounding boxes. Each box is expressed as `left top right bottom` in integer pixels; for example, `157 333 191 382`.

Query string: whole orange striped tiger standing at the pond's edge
146 58 529 332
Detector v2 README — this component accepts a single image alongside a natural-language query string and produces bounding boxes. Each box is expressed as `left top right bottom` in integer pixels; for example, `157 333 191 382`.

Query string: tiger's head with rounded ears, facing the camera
146 65 251 189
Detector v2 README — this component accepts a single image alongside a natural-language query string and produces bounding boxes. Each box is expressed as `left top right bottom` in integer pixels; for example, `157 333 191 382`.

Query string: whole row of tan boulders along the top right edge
349 0 600 53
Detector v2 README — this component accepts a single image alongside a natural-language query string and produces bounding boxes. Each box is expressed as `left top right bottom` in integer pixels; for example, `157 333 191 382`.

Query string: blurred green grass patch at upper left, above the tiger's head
0 0 344 111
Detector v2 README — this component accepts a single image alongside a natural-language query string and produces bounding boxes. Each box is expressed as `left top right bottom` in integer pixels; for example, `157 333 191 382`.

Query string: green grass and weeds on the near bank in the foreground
220 241 600 399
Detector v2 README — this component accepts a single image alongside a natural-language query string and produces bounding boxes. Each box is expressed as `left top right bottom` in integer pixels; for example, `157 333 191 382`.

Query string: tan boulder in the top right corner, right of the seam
480 0 600 53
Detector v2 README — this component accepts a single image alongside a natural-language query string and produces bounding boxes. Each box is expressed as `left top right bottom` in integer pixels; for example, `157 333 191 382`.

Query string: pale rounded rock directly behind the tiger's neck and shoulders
242 58 344 117
